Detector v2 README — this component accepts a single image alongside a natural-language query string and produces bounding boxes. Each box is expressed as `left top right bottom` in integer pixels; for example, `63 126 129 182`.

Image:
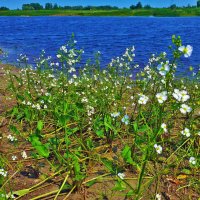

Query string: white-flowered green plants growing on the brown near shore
0 36 200 200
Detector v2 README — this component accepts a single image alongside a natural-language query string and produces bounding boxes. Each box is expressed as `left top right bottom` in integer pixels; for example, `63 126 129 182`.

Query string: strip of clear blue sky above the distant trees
0 0 197 9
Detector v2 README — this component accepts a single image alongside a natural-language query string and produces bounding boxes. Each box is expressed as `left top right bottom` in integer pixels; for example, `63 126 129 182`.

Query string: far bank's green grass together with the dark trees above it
0 1 200 16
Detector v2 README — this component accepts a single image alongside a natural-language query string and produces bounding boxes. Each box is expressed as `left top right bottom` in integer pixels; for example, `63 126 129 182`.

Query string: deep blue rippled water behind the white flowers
0 17 200 72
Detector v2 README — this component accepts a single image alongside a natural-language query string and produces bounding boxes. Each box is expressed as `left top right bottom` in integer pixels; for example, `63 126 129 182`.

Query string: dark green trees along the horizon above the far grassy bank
0 0 200 10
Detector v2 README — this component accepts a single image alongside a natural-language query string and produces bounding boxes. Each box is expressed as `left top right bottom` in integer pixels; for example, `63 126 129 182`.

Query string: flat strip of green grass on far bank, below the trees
0 8 200 17
